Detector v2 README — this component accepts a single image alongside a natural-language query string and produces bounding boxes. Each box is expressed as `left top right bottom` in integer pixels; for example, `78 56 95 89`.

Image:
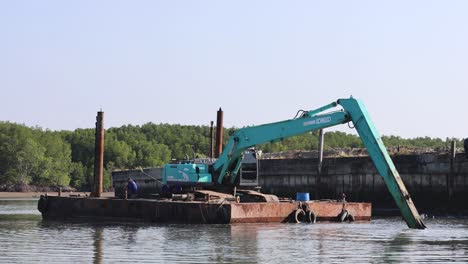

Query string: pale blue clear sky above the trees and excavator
0 0 468 139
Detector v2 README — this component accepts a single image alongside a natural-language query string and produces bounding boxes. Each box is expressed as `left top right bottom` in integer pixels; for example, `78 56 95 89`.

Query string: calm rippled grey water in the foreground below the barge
0 200 468 263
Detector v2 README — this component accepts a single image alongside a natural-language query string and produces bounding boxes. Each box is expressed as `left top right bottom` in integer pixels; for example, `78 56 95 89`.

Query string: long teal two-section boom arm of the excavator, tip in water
213 97 425 229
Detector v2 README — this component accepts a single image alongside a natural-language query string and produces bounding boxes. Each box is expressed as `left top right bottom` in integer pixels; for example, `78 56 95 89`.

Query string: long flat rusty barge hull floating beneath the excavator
38 196 372 224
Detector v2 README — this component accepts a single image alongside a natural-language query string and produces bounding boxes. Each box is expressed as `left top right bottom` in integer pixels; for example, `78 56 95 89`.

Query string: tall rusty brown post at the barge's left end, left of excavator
92 111 104 197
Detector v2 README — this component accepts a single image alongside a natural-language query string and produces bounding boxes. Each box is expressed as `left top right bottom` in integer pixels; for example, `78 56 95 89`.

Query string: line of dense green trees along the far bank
0 122 462 190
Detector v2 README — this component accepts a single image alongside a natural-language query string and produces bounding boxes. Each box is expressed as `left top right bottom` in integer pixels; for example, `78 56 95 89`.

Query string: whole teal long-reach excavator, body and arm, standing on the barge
163 97 426 229
